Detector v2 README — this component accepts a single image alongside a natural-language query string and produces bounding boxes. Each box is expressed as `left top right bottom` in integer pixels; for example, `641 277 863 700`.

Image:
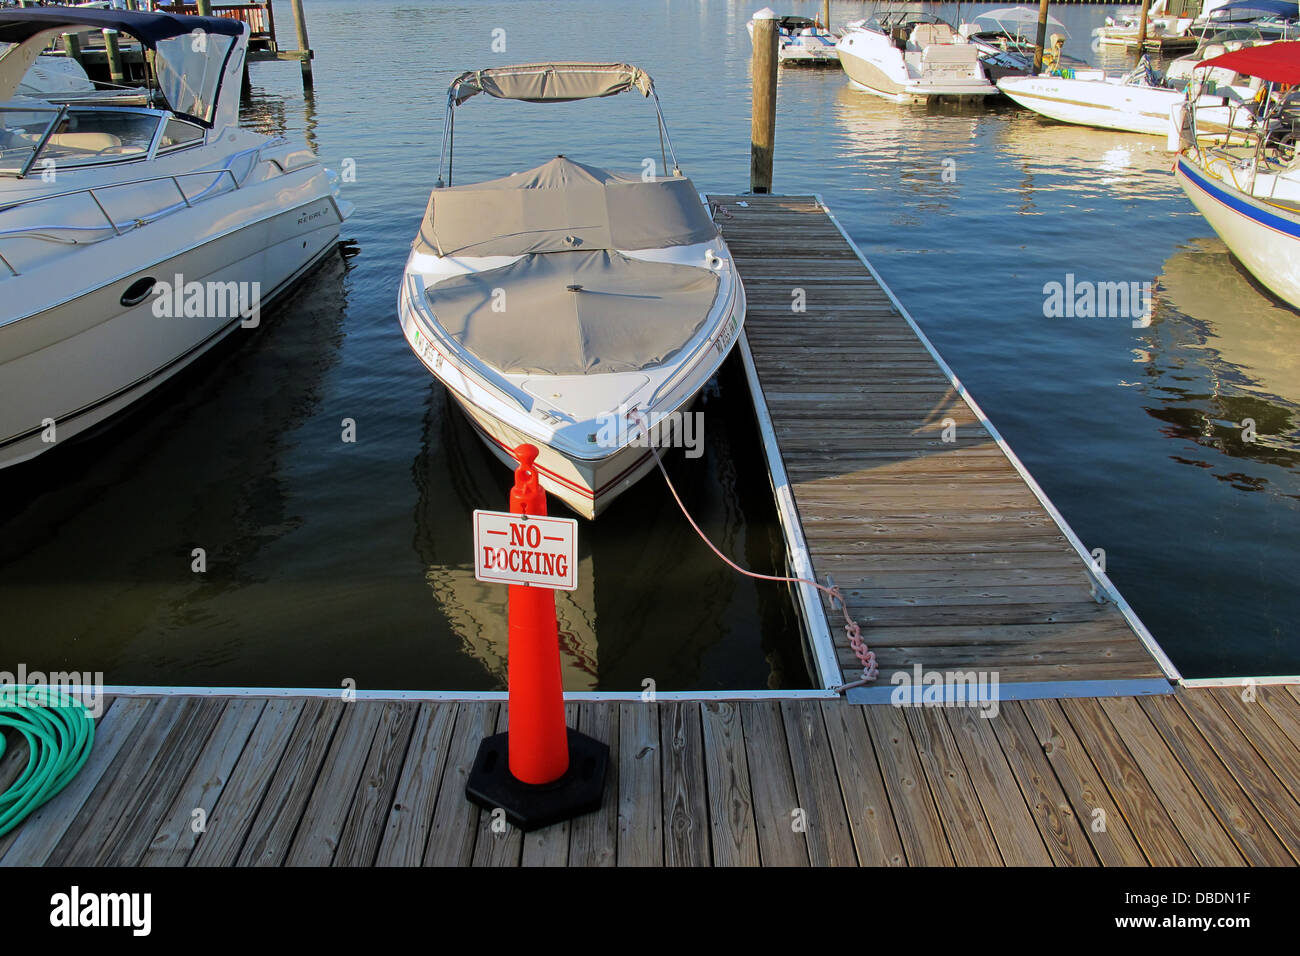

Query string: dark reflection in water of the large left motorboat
0 252 348 687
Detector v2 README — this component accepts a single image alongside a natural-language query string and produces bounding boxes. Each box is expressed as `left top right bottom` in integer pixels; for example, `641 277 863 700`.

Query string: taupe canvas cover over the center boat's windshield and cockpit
416 156 718 256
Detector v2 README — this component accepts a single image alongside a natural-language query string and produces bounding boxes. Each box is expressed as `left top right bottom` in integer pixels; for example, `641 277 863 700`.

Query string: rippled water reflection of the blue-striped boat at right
1135 238 1300 486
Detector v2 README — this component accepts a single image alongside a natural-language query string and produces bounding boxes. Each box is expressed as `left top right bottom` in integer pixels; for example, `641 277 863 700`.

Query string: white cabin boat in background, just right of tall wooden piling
836 13 997 103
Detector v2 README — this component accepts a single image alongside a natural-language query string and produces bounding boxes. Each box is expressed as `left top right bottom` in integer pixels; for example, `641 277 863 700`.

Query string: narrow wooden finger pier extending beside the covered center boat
710 195 1175 693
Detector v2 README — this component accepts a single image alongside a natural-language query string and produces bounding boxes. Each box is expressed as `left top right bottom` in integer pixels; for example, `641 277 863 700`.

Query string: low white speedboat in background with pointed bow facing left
997 57 1255 138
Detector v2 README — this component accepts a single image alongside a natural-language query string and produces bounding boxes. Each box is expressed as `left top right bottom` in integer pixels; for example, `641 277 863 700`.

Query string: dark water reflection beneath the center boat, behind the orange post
412 360 810 691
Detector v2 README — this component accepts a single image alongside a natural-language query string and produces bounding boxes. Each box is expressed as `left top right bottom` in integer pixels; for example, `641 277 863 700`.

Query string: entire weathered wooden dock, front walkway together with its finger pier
0 195 1300 866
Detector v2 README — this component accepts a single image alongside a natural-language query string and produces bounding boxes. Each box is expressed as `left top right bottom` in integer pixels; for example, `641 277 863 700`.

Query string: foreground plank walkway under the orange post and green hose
0 685 1300 866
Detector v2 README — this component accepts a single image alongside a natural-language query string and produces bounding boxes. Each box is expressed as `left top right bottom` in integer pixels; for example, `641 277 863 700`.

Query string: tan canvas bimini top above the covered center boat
449 62 654 107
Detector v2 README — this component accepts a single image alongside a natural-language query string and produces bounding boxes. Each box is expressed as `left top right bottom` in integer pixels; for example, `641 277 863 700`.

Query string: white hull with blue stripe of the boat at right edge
1174 157 1300 308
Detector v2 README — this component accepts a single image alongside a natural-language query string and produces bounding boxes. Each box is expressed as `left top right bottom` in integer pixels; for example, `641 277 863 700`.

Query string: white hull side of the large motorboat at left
0 184 342 467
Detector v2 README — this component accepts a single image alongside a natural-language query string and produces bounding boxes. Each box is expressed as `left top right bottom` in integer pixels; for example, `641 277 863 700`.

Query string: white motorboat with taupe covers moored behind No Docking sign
398 64 745 518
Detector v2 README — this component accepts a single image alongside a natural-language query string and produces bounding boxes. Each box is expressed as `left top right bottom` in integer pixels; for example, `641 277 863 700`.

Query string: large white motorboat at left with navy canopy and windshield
0 7 347 467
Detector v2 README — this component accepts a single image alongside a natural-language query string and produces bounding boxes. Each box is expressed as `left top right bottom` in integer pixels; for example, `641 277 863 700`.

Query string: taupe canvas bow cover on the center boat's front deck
425 250 718 375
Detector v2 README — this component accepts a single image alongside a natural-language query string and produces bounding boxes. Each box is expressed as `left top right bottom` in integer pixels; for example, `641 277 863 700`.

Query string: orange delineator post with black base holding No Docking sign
465 445 610 830
